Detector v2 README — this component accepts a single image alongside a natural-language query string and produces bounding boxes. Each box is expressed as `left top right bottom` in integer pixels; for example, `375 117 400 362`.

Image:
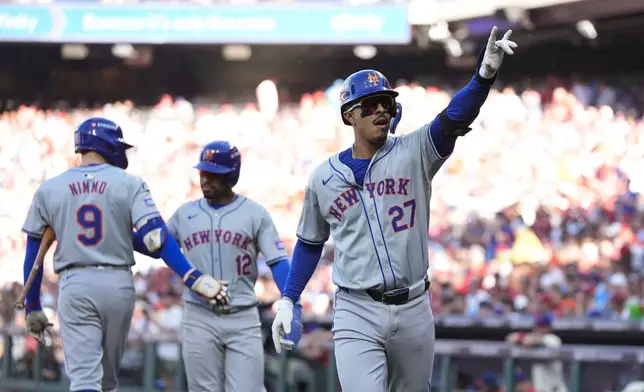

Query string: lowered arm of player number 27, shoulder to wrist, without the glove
283 175 330 303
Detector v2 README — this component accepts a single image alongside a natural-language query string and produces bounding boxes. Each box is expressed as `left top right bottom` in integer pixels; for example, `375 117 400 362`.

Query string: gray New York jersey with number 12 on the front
167 195 287 307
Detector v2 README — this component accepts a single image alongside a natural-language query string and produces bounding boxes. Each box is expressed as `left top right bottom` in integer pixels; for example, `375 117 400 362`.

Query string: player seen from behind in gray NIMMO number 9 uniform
22 118 229 392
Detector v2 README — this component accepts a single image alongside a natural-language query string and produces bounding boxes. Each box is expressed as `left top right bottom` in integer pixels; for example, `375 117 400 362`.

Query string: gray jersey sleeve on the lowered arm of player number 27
297 177 331 245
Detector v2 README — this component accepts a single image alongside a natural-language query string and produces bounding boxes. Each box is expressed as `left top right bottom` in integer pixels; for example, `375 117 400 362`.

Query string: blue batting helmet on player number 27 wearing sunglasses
340 69 398 125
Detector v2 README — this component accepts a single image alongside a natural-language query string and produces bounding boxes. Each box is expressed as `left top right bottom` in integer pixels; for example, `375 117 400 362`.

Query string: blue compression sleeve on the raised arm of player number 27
429 74 494 157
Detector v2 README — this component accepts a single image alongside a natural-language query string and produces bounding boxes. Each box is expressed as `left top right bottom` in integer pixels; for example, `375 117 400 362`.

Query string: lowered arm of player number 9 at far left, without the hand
22 188 50 313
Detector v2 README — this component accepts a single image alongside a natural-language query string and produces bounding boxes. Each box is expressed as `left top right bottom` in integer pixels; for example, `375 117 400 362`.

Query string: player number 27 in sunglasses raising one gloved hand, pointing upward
273 27 517 392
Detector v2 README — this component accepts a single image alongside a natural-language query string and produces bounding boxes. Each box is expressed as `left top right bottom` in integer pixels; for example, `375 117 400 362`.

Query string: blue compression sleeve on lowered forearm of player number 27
282 240 324 302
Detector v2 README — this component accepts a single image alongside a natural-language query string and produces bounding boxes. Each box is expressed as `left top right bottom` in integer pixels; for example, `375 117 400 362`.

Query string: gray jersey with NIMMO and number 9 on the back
22 164 159 271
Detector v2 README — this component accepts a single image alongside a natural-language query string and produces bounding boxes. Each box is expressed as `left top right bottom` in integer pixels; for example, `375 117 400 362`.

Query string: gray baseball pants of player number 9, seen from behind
58 267 135 392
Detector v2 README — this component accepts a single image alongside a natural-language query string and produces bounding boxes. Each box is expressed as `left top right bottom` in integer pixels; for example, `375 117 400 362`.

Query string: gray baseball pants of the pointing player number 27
332 290 435 392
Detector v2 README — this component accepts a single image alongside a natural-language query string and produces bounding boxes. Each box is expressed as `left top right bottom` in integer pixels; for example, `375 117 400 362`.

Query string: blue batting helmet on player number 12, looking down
195 140 241 187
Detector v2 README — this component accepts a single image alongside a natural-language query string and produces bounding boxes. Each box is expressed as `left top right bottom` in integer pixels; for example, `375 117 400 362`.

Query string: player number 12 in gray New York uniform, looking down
138 141 302 392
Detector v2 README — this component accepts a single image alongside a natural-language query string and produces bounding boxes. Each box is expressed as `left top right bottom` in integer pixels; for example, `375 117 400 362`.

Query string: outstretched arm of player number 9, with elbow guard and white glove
131 177 229 304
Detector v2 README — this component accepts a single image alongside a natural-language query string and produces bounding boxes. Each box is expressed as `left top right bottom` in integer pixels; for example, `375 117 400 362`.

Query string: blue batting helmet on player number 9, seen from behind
74 117 133 169
